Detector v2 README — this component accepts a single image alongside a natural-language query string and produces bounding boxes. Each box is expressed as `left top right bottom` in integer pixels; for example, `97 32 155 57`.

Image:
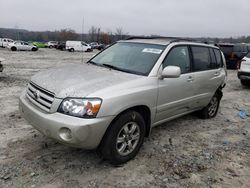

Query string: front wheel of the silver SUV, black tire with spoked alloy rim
98 111 146 165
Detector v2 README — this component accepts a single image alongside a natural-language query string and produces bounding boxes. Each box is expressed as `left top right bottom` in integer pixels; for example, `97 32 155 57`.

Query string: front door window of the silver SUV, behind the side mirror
163 46 190 74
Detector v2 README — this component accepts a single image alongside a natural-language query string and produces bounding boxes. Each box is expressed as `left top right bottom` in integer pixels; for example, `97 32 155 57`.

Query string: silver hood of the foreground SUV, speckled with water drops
31 64 141 98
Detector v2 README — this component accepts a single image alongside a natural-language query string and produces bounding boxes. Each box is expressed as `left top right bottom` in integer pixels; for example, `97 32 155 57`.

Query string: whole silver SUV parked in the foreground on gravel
20 38 226 164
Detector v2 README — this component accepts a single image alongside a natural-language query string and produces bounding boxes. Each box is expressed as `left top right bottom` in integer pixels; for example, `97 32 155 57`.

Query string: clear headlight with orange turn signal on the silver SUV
58 98 102 118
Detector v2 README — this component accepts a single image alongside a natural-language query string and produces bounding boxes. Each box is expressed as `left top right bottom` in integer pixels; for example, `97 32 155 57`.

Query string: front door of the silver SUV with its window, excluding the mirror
155 45 195 123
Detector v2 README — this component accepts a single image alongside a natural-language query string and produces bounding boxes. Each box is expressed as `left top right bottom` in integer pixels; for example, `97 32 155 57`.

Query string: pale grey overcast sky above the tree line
0 0 250 37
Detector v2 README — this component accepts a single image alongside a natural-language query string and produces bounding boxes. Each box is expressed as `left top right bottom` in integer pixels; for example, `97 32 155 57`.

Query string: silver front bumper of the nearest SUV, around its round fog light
19 93 114 149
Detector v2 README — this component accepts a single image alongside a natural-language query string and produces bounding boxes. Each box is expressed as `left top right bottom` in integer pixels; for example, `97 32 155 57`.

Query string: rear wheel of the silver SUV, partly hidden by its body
198 93 222 119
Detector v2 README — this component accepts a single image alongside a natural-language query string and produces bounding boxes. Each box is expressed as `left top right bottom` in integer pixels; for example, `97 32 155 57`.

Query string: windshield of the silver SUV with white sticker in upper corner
90 42 166 75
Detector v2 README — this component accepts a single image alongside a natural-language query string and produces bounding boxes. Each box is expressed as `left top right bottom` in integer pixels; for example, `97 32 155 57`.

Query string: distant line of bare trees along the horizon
0 26 250 44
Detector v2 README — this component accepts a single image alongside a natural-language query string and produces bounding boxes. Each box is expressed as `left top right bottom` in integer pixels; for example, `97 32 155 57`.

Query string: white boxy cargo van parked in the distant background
66 40 91 52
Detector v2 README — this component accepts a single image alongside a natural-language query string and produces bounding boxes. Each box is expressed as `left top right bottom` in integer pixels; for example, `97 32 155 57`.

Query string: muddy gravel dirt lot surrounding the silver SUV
0 49 250 188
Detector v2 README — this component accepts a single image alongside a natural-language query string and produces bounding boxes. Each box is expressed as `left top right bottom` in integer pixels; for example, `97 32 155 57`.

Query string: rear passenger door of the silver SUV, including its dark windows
190 46 225 108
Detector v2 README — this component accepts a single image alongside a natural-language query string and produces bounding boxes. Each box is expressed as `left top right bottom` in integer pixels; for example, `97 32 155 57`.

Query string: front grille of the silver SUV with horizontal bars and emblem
26 82 55 112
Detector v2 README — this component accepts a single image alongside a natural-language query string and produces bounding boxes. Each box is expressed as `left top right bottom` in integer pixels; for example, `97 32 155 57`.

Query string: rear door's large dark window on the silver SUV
191 46 211 71
